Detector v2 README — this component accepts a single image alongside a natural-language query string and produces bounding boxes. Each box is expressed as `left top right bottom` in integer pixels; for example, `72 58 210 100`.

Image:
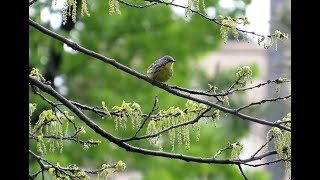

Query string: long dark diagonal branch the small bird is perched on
29 19 291 131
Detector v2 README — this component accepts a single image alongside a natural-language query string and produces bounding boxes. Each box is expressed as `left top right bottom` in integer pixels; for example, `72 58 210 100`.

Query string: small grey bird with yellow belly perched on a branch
147 55 176 82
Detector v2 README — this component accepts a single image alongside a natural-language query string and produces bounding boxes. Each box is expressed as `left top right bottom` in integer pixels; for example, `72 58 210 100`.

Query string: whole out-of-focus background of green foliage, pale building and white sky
29 0 291 180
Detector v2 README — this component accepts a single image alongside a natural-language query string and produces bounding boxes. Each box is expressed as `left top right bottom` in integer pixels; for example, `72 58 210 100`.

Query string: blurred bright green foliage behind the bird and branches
29 0 269 180
